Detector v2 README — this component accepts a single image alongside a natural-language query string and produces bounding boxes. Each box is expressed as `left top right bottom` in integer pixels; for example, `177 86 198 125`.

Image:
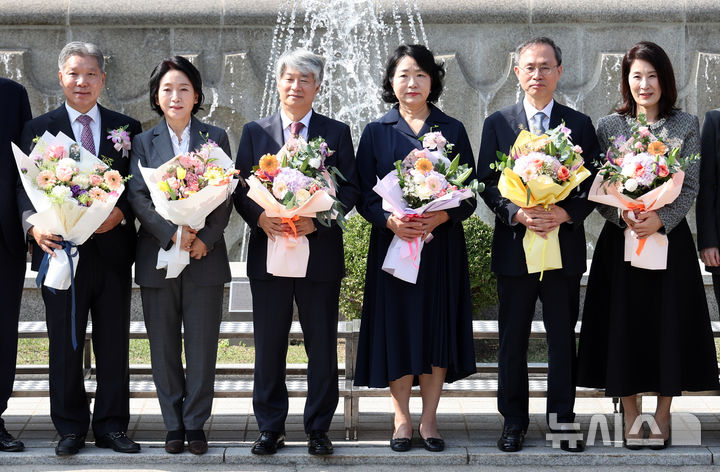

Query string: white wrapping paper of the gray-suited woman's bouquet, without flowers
138 147 238 279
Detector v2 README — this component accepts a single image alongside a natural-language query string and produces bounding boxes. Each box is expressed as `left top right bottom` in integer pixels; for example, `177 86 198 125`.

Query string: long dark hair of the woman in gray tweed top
616 41 677 118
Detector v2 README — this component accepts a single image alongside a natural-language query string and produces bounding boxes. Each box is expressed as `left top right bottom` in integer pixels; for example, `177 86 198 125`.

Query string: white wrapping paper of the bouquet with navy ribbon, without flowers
12 131 125 290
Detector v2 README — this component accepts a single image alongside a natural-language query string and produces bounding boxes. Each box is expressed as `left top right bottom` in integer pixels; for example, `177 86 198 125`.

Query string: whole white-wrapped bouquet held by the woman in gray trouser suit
139 141 238 279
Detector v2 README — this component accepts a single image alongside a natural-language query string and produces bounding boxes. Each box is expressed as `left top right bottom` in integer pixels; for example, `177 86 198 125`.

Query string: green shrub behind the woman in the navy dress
340 214 497 320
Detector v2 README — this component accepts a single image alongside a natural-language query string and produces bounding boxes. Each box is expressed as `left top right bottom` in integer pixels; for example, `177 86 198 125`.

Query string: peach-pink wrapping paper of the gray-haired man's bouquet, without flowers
247 175 335 277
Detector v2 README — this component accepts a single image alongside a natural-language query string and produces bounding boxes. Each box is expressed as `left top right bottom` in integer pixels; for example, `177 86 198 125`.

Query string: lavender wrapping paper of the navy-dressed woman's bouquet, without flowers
373 171 473 284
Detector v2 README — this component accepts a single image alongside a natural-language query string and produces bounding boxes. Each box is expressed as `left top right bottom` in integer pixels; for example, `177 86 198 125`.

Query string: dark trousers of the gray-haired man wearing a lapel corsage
42 239 131 437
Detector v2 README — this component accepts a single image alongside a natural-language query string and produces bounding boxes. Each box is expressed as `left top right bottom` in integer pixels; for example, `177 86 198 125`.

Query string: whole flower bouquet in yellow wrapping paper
490 124 590 280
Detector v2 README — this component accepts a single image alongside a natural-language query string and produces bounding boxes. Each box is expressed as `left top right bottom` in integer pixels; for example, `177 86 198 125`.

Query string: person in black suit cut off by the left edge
0 78 32 452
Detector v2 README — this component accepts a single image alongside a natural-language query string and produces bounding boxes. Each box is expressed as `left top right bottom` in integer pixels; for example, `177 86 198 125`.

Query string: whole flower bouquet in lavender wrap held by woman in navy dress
373 131 483 284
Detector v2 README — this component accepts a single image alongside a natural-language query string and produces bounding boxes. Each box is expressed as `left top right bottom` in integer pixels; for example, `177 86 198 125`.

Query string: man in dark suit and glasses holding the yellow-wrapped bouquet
477 38 599 452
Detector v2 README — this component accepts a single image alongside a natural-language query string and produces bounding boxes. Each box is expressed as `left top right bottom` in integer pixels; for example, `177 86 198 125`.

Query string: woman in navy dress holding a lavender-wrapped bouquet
355 45 477 451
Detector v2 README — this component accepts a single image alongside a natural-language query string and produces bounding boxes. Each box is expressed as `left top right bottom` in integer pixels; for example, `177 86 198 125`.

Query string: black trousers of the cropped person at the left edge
0 240 25 427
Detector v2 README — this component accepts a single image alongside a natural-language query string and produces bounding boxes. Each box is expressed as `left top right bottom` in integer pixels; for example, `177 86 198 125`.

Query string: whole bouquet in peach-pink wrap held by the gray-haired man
247 137 344 277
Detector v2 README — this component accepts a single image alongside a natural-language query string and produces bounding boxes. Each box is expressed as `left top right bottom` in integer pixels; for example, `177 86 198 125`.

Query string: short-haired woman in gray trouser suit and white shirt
129 56 232 454
